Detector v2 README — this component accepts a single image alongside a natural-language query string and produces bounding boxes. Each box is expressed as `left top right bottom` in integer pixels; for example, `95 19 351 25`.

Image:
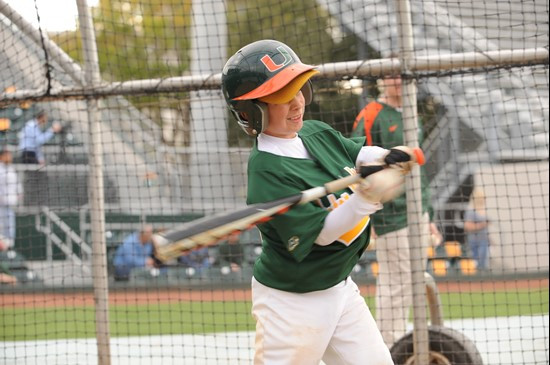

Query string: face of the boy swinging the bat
264 91 306 138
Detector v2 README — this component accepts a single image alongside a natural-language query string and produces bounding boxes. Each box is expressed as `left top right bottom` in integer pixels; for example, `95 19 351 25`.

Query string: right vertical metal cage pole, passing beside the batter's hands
395 0 429 365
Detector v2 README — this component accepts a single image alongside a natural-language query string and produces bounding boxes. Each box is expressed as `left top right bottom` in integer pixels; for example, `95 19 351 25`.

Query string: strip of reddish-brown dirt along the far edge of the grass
0 278 549 308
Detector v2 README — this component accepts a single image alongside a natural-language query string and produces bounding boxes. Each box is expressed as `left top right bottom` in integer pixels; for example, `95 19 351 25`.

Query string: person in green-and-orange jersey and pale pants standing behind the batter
351 69 443 347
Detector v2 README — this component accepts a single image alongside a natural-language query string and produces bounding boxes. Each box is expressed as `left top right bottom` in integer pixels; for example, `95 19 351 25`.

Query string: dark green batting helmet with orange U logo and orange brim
222 39 319 136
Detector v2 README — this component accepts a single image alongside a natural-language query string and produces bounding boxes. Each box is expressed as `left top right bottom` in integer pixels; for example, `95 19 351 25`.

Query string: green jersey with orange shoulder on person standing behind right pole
352 101 433 235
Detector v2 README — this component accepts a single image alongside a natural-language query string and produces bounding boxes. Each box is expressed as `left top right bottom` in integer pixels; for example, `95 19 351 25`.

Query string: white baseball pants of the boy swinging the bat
252 278 393 365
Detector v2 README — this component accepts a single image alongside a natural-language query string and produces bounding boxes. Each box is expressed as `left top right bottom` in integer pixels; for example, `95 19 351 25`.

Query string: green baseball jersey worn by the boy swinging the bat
247 120 370 293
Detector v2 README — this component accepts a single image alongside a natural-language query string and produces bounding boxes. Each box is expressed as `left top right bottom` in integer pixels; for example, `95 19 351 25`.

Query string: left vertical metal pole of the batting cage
76 0 111 365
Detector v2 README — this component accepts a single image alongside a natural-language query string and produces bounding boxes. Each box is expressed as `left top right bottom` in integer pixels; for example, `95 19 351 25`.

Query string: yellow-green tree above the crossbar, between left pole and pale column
93 0 191 81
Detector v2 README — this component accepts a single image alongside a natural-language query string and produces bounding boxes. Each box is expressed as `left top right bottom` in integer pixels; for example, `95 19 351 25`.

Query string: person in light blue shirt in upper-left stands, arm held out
19 110 62 165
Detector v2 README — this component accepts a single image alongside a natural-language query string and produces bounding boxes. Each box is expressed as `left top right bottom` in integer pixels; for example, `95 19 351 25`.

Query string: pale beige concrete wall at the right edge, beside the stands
475 161 549 272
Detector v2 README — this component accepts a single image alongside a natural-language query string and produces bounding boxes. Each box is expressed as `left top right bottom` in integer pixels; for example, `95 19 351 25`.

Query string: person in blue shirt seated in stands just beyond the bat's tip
113 225 156 280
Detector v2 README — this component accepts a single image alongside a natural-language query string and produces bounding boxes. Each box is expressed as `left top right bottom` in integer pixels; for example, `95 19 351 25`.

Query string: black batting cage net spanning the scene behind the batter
0 0 549 365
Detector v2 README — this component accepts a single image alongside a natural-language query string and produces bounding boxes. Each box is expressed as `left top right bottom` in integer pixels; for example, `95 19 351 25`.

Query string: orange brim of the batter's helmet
233 63 319 104
